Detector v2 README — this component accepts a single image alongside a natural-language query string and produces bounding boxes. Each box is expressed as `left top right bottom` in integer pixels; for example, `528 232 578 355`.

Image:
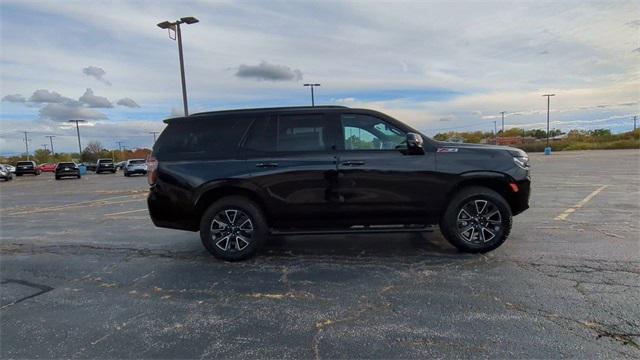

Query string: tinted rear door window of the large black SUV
245 114 329 152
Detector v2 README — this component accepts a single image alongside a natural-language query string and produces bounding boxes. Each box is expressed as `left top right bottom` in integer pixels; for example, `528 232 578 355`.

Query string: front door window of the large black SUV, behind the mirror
342 114 406 150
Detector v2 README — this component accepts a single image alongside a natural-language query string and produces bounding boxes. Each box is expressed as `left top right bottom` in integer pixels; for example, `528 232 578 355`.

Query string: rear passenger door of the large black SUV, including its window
245 113 338 227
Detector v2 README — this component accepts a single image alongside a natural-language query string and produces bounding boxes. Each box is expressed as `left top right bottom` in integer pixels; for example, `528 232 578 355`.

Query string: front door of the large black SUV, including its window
338 114 437 224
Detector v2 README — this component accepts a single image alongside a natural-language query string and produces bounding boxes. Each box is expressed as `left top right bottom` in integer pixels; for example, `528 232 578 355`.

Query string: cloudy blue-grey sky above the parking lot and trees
0 0 640 155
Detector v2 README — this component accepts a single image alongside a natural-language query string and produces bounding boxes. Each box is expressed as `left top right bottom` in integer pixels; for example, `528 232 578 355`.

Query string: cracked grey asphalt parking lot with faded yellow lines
0 150 640 358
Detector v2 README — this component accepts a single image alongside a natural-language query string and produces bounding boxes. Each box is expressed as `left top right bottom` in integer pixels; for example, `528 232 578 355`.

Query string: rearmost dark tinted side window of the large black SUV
154 117 253 160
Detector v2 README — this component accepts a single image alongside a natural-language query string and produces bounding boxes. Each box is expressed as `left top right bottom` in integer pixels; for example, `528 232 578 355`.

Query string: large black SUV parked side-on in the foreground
148 106 530 260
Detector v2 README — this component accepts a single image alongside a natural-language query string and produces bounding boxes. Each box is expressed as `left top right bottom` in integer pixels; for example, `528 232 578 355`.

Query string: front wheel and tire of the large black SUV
440 186 512 253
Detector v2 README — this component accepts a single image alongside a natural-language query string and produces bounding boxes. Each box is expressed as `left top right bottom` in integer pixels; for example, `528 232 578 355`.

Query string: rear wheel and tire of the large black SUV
200 196 268 261
